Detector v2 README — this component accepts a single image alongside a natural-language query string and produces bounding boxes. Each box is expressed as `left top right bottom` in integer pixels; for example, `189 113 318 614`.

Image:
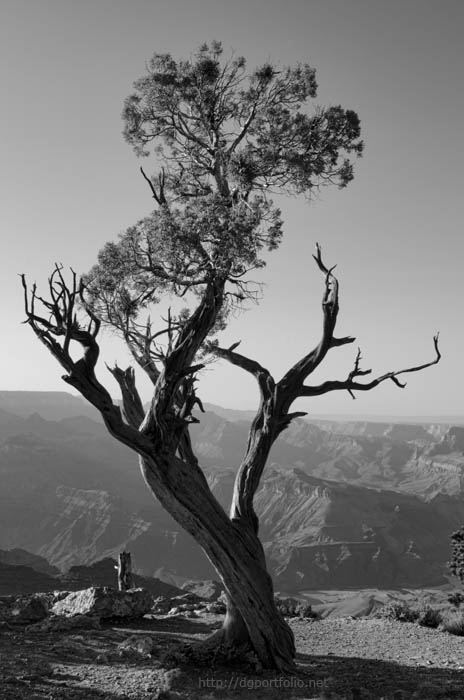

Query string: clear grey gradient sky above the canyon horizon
0 0 464 416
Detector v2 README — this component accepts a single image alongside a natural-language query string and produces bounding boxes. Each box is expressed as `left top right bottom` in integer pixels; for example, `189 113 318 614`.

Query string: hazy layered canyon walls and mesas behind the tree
0 392 464 592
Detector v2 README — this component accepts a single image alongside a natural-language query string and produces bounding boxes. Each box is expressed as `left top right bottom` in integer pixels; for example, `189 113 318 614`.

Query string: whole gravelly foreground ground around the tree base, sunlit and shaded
0 613 464 700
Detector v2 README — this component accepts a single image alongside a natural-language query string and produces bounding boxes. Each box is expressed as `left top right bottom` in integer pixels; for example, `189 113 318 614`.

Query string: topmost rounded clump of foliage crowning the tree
123 42 362 200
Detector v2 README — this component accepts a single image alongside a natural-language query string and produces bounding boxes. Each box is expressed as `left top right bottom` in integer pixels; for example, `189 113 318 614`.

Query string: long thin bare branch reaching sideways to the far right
299 333 441 399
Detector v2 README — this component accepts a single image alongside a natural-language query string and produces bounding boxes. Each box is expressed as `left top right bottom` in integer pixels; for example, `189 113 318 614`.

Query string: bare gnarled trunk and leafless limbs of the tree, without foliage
22 242 440 671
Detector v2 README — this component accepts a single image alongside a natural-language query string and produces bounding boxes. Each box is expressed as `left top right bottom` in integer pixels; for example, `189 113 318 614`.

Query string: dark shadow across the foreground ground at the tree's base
0 617 464 700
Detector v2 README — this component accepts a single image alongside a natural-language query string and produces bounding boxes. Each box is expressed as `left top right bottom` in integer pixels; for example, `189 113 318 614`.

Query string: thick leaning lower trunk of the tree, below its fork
141 455 295 671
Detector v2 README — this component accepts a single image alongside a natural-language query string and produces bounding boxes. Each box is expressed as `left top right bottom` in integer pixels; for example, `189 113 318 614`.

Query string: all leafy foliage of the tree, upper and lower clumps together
85 42 363 352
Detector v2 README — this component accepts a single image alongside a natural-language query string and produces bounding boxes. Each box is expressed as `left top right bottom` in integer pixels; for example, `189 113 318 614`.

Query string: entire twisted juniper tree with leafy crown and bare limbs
23 43 440 670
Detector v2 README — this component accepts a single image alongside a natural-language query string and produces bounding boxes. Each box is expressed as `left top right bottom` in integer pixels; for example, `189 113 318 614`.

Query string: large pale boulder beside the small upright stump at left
51 586 153 620
